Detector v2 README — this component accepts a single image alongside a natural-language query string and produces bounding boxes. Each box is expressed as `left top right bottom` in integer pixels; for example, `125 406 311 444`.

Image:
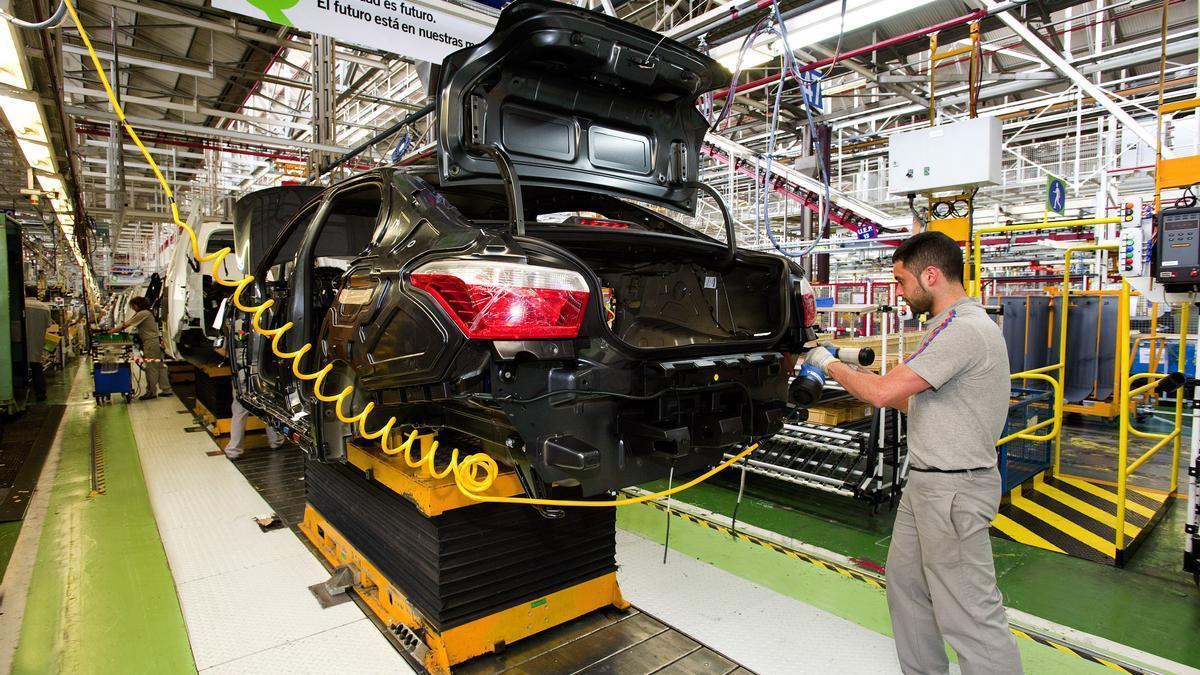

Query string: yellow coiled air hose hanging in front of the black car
62 0 758 507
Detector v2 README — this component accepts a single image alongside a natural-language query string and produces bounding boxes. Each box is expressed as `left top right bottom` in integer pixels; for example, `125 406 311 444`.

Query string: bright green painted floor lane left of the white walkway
4 366 196 673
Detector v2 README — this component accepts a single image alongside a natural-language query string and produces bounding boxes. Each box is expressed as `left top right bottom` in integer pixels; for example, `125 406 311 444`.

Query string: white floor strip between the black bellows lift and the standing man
617 530 902 675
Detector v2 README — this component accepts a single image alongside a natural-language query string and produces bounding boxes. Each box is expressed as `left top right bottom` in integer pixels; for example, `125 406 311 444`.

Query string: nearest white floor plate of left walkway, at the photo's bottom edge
204 619 412 675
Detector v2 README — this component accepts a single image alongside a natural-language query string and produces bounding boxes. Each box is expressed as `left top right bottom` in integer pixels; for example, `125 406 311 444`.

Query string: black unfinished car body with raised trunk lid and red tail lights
234 1 816 496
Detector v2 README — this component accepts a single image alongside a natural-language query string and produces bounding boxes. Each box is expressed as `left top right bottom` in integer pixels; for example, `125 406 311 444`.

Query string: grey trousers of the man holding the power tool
887 468 1021 675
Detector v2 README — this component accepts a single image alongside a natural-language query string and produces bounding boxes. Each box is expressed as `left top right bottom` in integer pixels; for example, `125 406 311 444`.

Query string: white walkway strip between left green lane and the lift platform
130 398 410 673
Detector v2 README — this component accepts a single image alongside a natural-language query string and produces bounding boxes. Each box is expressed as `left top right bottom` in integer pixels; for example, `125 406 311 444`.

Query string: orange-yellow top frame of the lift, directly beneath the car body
346 434 524 518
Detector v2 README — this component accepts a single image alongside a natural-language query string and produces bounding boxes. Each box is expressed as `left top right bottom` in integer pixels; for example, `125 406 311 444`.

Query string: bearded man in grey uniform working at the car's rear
805 232 1021 675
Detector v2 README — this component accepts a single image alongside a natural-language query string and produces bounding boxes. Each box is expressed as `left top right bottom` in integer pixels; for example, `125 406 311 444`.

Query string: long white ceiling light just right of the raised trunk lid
710 0 934 70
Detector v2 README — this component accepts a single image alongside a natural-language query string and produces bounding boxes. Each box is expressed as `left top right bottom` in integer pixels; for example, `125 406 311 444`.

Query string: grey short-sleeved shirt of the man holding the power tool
905 298 1009 471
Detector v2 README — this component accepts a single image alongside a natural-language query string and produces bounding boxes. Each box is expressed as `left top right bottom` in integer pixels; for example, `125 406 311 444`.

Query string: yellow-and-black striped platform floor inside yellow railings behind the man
992 474 1169 565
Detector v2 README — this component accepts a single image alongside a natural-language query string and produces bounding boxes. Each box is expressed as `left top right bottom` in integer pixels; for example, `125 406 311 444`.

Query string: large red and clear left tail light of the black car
412 261 588 340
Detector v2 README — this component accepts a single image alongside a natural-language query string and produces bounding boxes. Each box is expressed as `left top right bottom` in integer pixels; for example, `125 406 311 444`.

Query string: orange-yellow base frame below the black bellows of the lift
300 506 629 675
